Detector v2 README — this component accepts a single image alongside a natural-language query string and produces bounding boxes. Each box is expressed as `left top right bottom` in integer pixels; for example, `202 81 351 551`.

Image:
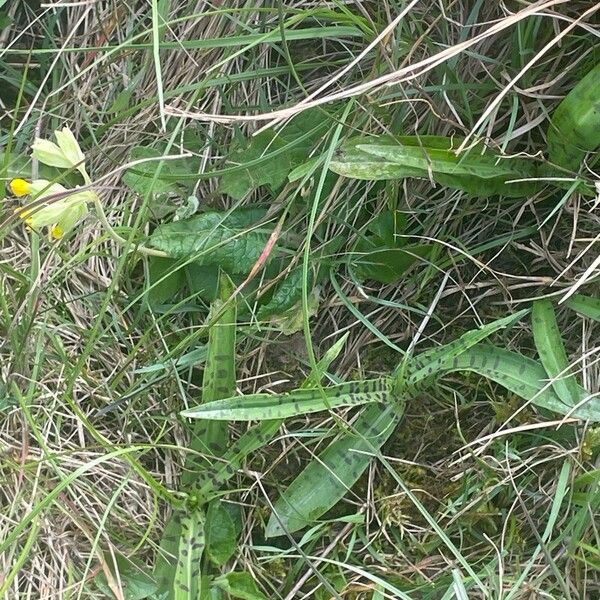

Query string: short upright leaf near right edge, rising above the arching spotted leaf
531 299 579 406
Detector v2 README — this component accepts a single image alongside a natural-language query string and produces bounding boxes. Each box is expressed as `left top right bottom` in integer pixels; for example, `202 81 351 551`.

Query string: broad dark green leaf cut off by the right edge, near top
547 64 600 171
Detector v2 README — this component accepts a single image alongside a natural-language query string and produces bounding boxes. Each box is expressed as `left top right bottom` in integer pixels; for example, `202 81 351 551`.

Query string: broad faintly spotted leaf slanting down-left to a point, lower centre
265 402 404 537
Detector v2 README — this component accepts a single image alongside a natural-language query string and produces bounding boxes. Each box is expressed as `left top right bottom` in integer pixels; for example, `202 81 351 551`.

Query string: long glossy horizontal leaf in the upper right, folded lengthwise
330 135 537 197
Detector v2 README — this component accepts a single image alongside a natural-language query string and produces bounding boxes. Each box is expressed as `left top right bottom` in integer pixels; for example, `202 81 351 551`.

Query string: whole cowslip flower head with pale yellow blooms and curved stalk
9 127 167 257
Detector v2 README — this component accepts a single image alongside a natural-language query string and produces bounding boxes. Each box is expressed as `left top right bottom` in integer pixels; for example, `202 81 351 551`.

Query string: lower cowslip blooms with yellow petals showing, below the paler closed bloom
10 179 97 239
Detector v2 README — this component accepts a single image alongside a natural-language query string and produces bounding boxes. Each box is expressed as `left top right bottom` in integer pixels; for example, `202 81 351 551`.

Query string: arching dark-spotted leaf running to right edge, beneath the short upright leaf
445 344 600 421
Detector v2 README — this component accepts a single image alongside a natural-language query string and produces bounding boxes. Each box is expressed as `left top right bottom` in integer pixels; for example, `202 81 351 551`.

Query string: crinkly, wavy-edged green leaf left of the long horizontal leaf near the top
219 109 329 200
